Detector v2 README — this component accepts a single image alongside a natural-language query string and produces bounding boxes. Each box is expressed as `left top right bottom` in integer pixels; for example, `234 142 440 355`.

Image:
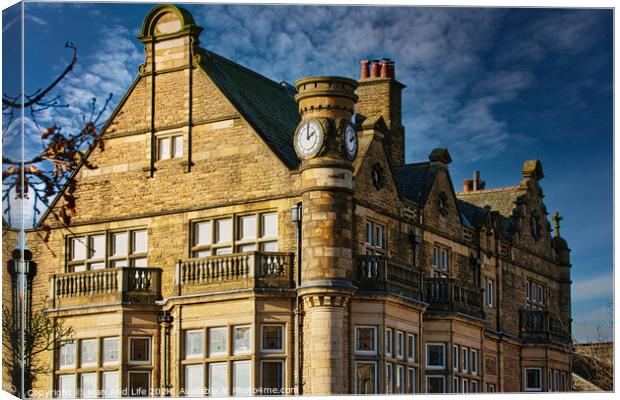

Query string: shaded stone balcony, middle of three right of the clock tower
424 278 484 318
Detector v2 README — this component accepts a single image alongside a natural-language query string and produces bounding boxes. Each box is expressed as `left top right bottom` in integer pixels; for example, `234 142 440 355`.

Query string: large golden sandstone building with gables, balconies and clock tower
9 5 571 397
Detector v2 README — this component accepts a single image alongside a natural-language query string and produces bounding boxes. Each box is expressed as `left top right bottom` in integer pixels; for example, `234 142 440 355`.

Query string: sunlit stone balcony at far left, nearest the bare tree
49 268 161 308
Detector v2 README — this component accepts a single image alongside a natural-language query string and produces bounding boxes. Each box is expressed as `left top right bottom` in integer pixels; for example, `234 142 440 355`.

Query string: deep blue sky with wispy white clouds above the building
3 3 613 340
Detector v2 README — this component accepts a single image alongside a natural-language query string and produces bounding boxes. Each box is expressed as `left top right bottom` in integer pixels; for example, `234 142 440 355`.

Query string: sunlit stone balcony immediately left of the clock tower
175 251 295 295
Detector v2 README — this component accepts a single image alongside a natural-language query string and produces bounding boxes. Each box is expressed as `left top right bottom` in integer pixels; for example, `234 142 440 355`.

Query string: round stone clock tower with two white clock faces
294 77 357 394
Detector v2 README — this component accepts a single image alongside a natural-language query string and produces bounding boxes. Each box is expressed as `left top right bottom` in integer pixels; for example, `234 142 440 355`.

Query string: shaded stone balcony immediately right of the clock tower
353 255 422 300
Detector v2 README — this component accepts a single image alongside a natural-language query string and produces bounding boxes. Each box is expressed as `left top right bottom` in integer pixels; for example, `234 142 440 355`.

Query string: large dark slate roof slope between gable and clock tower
200 49 301 168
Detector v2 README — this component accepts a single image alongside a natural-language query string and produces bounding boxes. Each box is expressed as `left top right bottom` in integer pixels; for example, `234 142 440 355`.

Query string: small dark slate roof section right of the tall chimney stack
394 162 439 204
